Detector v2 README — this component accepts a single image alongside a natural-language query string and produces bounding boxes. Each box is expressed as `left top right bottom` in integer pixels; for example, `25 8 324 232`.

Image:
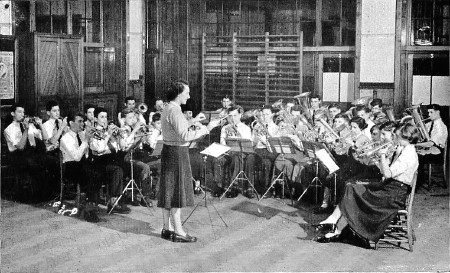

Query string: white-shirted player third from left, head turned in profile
60 113 100 202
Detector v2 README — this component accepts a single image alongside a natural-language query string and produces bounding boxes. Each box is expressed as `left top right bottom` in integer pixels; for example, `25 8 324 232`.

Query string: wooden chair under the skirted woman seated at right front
375 172 417 252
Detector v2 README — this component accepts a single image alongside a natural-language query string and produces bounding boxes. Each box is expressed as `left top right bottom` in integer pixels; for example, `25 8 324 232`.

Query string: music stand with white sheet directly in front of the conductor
181 143 229 238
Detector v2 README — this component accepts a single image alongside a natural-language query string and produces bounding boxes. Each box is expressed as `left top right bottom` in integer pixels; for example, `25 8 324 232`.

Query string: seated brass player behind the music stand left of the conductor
119 108 150 206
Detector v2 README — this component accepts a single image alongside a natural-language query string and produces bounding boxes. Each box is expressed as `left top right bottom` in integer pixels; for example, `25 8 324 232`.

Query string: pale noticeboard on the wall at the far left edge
0 51 14 99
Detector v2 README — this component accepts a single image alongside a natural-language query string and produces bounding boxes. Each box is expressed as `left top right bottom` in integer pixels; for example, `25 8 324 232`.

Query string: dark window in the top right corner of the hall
411 0 450 46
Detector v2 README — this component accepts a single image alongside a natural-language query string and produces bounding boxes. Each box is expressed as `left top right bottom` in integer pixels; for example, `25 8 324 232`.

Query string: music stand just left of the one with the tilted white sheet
260 137 295 202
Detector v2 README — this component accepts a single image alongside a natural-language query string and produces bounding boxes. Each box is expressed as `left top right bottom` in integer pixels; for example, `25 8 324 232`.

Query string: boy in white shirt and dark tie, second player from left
42 100 67 153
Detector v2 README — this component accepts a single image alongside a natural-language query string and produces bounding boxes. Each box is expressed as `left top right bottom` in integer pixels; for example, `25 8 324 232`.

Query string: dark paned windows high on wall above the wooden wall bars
205 0 356 46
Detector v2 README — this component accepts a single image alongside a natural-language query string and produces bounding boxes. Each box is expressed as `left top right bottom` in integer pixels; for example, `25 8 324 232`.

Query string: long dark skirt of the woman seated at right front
339 179 409 242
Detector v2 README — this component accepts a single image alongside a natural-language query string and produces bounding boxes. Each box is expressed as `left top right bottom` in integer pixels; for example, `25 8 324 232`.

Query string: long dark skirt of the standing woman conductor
158 145 194 209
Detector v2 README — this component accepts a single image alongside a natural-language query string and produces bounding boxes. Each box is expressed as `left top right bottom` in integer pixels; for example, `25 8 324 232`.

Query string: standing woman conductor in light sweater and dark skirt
158 80 219 242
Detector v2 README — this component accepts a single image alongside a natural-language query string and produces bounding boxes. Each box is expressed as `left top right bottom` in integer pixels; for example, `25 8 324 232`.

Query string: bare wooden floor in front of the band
1 178 450 272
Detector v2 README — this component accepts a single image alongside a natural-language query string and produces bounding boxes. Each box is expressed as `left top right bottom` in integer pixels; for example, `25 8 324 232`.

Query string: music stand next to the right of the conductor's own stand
219 138 260 201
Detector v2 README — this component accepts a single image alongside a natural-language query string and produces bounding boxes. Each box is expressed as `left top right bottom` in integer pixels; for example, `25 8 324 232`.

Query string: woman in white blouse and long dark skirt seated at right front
316 124 419 245
